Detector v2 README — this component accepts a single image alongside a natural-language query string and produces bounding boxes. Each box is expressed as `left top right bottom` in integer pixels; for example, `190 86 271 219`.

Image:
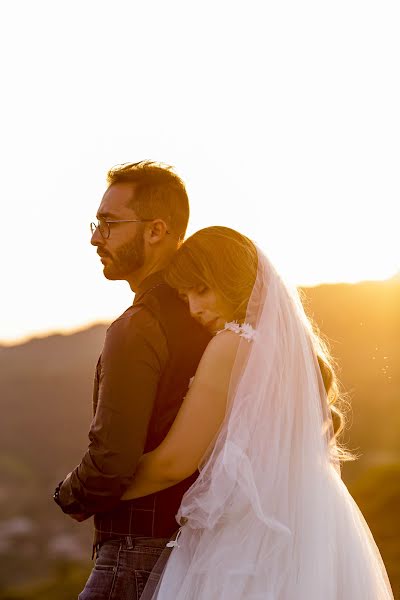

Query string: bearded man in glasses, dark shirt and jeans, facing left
54 161 209 600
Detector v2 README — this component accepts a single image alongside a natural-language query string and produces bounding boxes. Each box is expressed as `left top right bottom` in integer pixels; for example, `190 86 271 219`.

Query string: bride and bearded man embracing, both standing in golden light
54 161 393 600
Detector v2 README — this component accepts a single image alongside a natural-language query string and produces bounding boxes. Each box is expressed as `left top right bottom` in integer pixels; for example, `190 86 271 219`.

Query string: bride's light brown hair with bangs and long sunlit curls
165 226 351 460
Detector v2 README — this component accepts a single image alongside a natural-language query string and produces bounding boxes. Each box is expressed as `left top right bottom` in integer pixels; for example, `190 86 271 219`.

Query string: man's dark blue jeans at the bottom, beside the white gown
78 536 169 600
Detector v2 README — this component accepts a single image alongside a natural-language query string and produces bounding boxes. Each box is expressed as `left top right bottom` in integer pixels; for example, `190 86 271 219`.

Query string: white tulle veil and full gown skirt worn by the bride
142 251 393 600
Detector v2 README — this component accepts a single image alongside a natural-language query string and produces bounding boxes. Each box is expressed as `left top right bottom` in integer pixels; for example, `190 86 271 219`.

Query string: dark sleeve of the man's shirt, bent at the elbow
59 308 168 514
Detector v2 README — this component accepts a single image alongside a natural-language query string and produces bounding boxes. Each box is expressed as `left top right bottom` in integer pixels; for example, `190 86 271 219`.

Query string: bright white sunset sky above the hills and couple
0 0 400 343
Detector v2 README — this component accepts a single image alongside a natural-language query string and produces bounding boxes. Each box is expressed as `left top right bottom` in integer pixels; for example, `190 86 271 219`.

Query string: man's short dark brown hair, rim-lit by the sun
107 160 189 240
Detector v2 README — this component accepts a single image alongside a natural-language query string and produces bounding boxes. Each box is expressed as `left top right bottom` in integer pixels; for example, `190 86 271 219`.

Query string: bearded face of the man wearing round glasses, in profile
91 183 145 279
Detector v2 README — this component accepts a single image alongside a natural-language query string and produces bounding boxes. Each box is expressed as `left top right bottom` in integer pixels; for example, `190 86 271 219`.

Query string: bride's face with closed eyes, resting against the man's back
178 285 234 334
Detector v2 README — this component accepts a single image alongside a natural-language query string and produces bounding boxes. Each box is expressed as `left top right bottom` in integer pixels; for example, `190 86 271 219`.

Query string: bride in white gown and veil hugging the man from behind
120 227 393 600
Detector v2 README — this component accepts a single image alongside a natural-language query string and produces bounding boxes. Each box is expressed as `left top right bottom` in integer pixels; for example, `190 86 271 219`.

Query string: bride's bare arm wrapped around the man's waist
122 331 240 500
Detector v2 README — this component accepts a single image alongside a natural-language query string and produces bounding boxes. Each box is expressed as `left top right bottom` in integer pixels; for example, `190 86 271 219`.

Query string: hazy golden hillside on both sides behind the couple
0 279 400 599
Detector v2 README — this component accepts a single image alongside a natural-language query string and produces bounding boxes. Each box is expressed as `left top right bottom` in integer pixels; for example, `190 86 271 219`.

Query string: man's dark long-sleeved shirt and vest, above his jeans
58 272 210 542
